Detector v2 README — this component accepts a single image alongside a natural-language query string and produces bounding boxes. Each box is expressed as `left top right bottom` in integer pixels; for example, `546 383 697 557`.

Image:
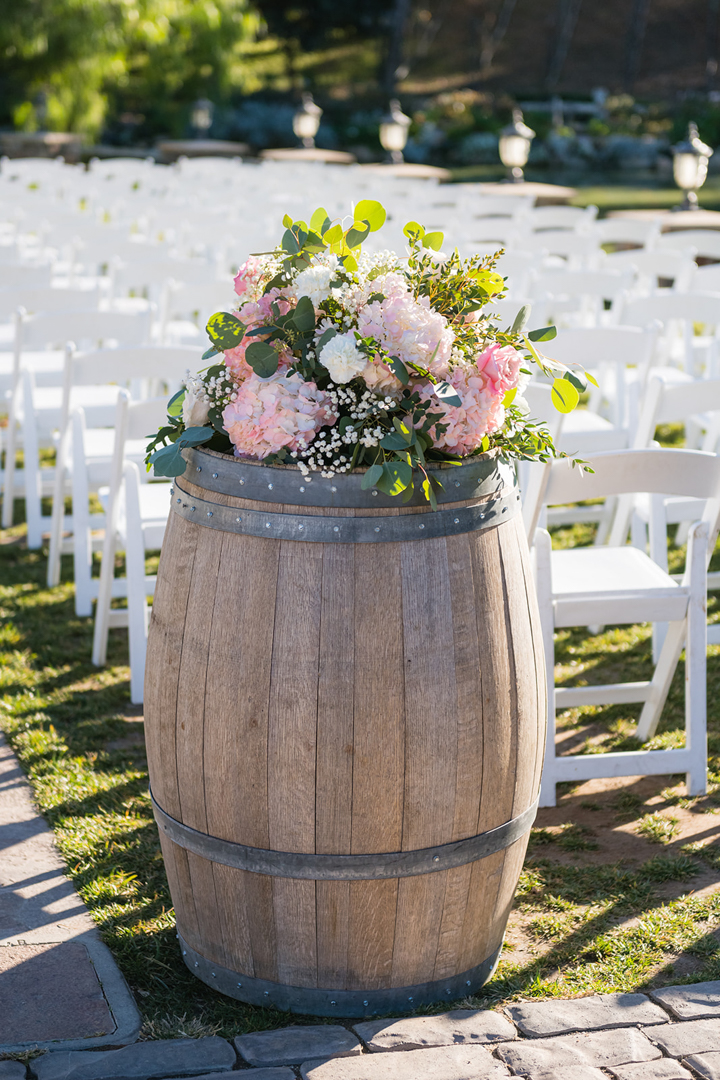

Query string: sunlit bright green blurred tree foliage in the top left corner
0 0 258 138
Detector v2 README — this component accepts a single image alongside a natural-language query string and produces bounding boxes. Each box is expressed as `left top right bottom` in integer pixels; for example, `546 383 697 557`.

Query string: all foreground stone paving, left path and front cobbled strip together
0 734 720 1080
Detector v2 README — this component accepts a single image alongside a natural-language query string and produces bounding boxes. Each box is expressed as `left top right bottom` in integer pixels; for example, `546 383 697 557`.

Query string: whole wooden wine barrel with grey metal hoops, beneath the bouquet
145 442 545 1016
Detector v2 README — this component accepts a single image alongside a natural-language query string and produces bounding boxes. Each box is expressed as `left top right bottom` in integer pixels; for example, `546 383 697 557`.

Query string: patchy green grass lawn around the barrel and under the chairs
0 494 720 1038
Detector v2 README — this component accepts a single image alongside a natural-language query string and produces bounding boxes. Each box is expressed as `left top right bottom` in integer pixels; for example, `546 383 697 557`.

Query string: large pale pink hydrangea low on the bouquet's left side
222 373 337 459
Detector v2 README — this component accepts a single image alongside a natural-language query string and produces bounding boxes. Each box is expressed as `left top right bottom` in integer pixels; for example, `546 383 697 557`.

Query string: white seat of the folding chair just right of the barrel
552 548 688 626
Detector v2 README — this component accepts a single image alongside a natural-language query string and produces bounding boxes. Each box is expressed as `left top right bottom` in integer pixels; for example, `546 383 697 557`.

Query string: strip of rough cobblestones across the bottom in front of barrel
7 980 720 1080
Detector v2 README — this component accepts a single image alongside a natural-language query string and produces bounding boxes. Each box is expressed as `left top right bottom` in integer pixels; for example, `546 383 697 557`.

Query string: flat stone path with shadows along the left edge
0 733 140 1049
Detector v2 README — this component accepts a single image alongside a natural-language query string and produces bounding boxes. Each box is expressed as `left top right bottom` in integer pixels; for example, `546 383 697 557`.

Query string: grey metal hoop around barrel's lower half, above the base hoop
150 793 538 881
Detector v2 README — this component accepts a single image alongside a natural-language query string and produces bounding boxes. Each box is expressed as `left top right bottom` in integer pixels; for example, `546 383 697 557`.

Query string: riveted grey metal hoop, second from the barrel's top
172 481 520 543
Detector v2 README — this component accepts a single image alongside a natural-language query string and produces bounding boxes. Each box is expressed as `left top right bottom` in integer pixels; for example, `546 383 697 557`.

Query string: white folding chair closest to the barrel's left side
93 391 173 704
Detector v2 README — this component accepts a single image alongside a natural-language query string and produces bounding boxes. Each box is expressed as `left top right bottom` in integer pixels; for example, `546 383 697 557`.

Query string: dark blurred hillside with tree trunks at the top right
402 0 720 98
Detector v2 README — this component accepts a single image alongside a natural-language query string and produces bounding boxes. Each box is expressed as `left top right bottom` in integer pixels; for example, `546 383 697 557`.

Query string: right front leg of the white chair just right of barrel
685 523 708 796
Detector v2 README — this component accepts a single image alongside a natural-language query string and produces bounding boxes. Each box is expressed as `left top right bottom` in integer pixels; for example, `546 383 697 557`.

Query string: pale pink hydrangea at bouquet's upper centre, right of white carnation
357 285 454 378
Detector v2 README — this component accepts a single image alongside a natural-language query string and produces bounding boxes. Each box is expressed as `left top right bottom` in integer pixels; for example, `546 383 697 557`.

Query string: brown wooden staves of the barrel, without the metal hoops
146 460 545 1006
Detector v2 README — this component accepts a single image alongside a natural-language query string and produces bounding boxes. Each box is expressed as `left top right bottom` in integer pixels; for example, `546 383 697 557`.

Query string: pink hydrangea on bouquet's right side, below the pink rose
420 366 505 457
